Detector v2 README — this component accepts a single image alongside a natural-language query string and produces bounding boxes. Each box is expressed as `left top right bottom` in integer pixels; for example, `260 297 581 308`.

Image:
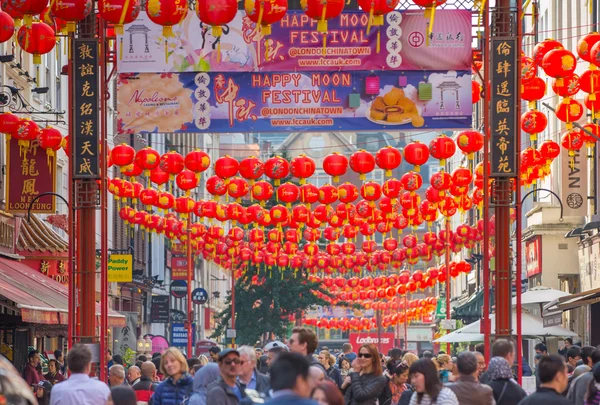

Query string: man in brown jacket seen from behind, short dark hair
448 352 495 405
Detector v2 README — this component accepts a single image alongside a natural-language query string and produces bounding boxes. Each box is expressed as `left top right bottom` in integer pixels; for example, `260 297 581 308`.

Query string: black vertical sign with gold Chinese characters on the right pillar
490 37 520 177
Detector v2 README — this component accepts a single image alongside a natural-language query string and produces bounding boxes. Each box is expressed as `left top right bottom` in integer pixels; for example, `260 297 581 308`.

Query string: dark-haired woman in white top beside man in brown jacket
408 359 459 405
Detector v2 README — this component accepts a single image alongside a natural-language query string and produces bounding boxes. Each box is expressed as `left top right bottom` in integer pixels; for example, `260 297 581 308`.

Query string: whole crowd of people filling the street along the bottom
0 327 600 405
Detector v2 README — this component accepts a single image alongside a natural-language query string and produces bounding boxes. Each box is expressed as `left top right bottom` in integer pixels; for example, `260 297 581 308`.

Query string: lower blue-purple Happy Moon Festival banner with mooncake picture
118 71 473 133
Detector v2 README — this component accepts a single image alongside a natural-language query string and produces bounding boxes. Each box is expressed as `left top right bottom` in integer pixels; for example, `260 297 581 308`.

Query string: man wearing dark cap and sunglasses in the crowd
206 349 246 405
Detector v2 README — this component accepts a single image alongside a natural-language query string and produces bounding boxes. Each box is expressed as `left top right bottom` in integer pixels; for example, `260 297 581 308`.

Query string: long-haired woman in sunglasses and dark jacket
342 343 385 405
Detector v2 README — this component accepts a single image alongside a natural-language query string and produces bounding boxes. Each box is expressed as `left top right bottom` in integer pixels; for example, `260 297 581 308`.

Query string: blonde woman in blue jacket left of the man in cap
152 347 194 405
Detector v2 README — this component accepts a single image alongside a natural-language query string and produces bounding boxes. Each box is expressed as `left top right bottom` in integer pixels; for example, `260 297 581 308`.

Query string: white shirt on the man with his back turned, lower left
50 374 110 405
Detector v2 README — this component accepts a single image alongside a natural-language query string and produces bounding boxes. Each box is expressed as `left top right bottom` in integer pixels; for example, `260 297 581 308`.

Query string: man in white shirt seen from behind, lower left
50 344 110 405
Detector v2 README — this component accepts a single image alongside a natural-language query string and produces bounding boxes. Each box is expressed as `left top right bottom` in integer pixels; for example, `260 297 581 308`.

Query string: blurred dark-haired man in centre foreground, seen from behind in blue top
267 353 317 405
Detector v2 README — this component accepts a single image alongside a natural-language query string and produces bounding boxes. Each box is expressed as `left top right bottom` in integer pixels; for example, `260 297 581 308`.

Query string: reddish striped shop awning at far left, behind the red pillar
0 258 127 327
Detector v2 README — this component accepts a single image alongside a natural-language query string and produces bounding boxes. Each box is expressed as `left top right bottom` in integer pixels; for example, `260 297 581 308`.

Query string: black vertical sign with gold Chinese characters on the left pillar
72 39 100 179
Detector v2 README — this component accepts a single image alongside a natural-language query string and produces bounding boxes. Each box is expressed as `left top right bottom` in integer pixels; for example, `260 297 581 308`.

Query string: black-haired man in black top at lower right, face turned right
519 355 571 405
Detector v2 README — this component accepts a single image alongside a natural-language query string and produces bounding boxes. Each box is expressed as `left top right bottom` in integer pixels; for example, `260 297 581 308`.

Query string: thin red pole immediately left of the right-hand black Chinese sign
481 1 491 364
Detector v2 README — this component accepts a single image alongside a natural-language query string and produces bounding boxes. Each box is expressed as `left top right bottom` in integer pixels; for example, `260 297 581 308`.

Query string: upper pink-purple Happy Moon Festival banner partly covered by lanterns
117 10 472 73
